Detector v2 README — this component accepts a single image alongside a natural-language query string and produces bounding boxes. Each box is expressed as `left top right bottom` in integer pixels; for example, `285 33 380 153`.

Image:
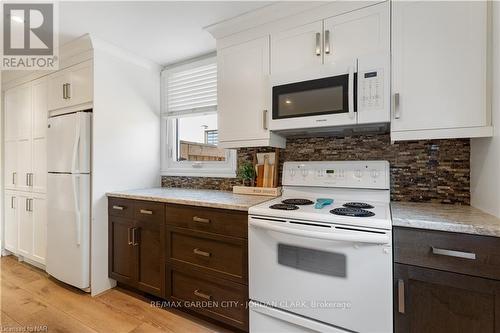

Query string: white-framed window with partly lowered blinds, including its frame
162 56 236 177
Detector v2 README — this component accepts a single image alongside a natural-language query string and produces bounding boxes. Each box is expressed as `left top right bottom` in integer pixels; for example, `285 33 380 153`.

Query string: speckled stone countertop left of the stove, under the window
106 187 273 211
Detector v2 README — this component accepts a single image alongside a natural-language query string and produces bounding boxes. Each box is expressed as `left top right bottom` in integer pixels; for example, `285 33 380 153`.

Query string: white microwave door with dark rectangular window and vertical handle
270 62 357 131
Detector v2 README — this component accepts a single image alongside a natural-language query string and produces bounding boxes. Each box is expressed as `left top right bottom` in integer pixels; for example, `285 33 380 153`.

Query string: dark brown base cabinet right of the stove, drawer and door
394 228 500 333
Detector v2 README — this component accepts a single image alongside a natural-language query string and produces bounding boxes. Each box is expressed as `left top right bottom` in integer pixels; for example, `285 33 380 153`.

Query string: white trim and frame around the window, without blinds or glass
160 53 237 178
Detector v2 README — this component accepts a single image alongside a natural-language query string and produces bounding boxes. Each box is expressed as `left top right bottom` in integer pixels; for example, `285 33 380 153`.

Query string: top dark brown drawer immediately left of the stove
166 205 248 238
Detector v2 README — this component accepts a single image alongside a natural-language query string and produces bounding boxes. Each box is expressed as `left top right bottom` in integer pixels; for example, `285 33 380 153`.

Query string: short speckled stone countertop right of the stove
391 202 500 237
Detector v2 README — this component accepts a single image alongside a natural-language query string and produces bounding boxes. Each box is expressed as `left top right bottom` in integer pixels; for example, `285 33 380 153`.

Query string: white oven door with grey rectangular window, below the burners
248 216 392 333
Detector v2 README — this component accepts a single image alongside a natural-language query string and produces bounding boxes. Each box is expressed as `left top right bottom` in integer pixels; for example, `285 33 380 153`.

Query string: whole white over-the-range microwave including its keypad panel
269 54 390 133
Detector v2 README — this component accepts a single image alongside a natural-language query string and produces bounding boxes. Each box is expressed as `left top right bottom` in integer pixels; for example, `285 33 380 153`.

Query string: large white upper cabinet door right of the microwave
391 1 489 132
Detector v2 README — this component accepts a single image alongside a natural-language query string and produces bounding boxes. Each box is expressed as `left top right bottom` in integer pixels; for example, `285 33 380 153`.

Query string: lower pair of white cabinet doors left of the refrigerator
4 191 47 265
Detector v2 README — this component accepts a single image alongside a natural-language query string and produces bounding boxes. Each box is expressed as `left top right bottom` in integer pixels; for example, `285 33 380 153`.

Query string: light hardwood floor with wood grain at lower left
0 256 234 333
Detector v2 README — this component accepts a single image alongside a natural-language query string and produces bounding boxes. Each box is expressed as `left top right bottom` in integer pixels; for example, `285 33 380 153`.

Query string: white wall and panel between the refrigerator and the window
91 39 161 295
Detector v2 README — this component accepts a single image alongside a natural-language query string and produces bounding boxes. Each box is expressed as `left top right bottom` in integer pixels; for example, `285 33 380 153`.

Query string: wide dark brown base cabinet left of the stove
108 197 248 331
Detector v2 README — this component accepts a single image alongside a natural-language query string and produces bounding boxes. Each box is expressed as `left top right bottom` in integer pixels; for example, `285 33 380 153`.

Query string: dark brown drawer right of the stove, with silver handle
394 228 500 280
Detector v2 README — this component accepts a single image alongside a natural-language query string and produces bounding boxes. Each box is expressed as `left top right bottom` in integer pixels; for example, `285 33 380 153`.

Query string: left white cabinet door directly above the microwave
271 21 323 76
